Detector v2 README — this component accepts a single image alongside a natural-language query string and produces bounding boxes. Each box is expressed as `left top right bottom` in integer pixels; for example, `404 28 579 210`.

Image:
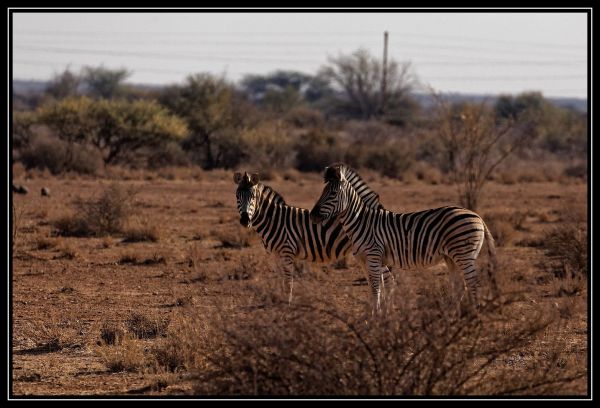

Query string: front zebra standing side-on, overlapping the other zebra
310 164 498 309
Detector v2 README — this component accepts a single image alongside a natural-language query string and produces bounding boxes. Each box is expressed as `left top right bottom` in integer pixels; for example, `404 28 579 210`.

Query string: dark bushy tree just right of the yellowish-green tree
160 74 251 169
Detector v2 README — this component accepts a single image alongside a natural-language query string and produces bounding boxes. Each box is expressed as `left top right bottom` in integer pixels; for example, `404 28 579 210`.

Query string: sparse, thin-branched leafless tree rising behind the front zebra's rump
434 95 536 211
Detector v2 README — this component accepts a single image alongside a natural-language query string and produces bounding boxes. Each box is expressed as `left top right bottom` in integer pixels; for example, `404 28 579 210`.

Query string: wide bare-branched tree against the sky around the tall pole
319 49 416 123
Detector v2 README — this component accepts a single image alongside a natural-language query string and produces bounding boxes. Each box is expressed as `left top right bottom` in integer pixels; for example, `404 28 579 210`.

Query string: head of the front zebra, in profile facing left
310 165 348 224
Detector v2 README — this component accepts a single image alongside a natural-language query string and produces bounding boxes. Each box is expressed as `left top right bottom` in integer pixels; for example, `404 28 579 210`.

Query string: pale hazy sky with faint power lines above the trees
12 9 587 97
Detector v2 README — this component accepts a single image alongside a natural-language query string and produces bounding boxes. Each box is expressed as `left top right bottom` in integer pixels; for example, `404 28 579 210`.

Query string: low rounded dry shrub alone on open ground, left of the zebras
53 184 136 236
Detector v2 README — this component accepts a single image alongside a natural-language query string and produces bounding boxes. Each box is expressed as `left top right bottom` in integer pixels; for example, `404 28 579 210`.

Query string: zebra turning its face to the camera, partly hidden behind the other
233 172 383 302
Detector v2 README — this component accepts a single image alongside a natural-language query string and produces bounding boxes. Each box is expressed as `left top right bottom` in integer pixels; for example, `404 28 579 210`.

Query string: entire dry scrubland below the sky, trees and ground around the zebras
10 47 591 397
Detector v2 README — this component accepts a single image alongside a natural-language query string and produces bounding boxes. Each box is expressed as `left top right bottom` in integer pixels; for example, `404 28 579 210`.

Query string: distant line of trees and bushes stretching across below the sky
12 50 587 207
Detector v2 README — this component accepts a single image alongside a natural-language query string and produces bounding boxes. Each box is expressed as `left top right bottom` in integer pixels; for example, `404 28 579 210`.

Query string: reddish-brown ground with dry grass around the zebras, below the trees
12 171 589 396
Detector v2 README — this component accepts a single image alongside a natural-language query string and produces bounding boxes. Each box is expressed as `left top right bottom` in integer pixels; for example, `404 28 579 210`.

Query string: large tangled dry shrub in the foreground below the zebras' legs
194 285 586 396
